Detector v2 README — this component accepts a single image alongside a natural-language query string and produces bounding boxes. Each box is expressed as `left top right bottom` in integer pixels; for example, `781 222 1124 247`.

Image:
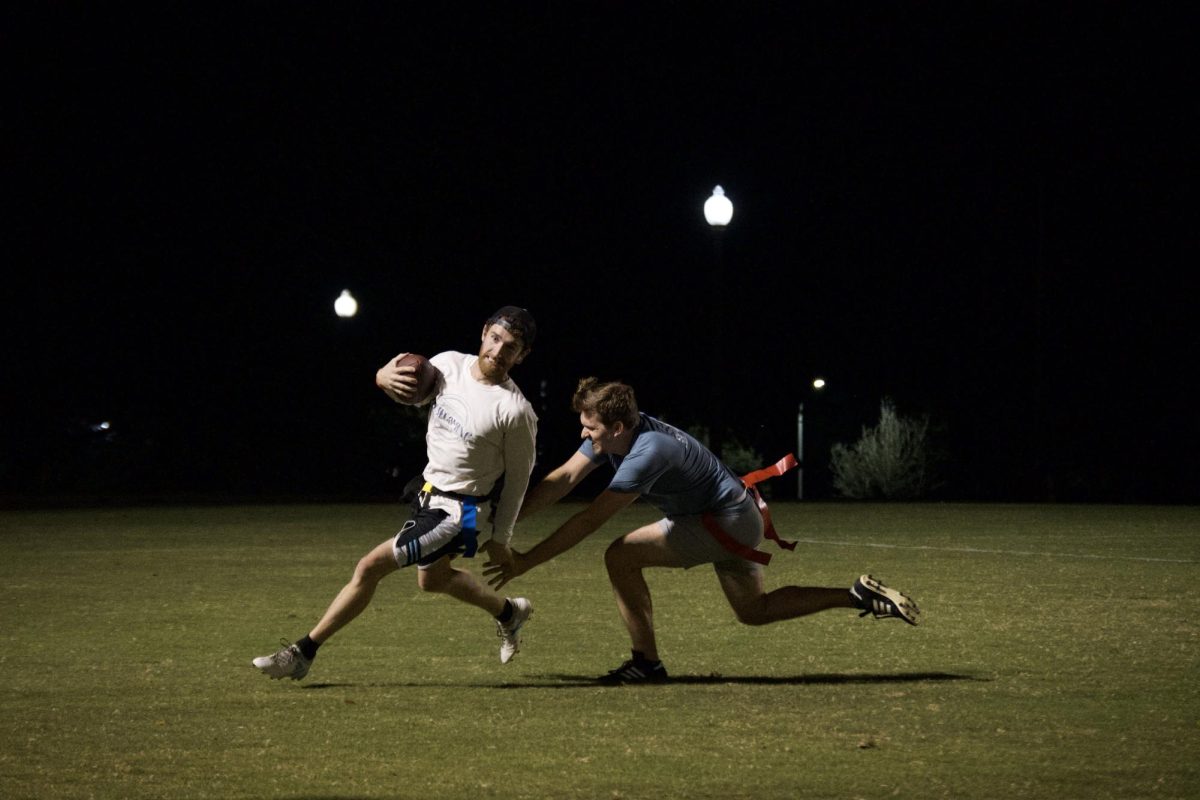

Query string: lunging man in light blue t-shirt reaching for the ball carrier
484 378 919 684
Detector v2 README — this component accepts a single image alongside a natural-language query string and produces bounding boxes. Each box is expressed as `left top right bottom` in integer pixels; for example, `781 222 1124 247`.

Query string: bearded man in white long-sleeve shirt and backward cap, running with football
253 306 538 680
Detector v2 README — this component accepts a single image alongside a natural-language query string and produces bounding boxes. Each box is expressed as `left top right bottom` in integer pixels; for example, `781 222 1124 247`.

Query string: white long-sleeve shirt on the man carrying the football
424 350 538 543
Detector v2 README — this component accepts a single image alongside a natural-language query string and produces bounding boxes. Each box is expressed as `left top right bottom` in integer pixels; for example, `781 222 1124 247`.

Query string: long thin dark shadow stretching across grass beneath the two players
304 672 991 690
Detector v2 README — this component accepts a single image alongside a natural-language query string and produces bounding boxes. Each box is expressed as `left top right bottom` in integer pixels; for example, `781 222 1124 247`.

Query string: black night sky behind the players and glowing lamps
0 2 1200 503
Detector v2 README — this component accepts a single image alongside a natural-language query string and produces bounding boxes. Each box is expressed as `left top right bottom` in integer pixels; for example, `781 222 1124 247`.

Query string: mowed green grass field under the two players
0 503 1200 800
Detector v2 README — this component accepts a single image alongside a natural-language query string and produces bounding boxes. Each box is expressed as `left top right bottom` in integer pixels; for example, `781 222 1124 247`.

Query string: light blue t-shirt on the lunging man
580 414 745 517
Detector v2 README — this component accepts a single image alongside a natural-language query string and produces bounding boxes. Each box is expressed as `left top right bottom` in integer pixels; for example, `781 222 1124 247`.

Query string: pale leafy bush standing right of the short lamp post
830 398 936 500
